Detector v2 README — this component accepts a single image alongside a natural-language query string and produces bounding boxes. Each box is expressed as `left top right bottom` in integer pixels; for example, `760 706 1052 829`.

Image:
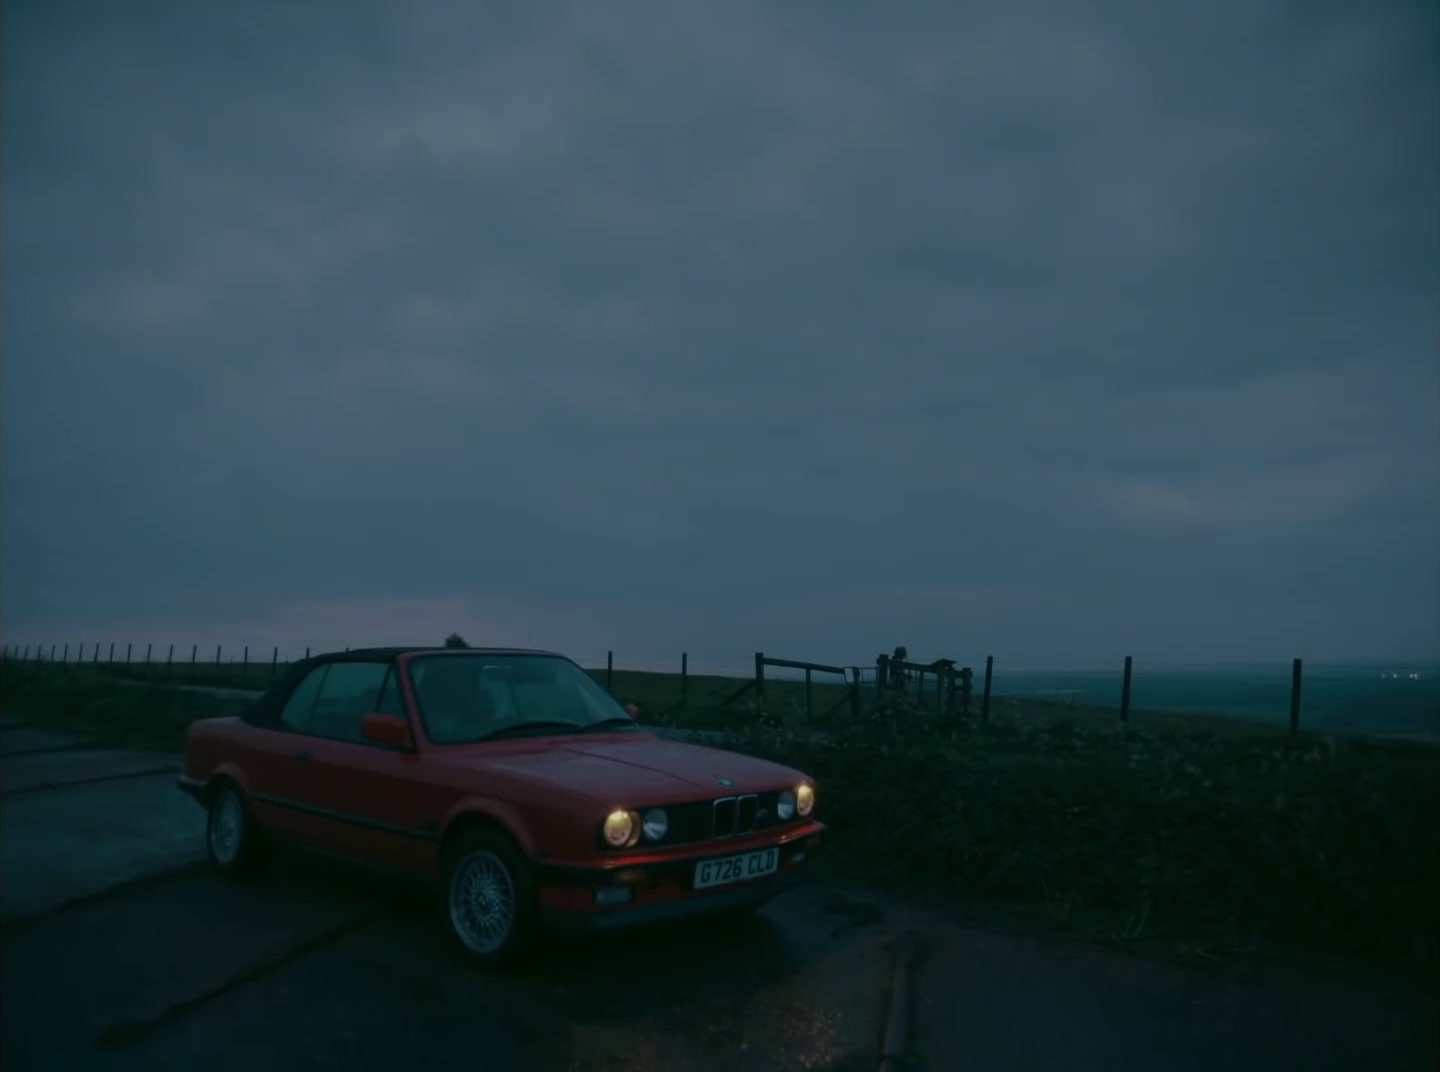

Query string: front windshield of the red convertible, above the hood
410 653 634 745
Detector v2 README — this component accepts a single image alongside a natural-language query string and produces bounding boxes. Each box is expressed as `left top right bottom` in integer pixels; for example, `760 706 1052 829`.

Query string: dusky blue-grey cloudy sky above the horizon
0 0 1440 667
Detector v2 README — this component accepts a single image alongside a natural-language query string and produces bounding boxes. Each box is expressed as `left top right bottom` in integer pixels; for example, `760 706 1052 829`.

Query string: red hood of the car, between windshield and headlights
434 732 804 805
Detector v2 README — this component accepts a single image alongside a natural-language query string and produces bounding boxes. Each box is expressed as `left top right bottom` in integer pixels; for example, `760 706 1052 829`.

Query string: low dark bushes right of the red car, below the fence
717 708 1440 980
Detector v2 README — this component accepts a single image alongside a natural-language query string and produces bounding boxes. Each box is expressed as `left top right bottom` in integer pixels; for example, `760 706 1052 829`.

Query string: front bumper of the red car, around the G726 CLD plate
533 823 825 931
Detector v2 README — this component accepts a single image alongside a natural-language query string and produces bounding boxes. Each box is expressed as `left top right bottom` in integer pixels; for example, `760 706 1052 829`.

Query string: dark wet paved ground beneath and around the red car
0 711 1440 1072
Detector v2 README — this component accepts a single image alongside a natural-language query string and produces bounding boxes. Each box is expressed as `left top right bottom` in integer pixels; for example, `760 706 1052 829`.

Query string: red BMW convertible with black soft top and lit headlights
179 648 825 965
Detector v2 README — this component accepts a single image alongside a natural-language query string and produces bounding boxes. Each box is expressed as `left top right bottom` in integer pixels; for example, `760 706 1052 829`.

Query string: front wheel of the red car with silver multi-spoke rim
445 831 539 971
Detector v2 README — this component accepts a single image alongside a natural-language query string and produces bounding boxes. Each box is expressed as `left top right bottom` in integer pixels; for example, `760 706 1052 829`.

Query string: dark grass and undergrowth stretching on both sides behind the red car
0 663 1440 984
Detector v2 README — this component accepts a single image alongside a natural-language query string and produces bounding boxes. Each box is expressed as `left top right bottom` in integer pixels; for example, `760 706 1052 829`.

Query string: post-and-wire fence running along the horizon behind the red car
0 641 1440 738
